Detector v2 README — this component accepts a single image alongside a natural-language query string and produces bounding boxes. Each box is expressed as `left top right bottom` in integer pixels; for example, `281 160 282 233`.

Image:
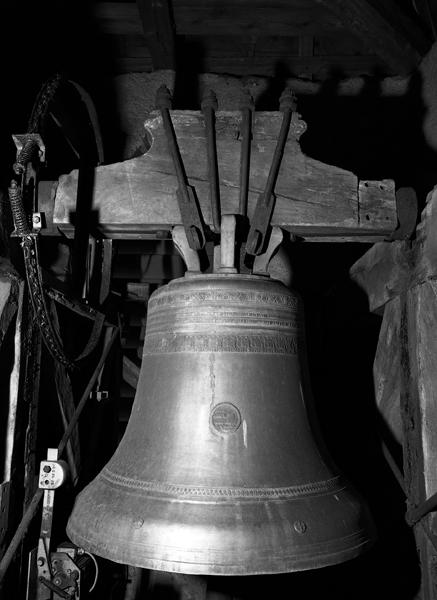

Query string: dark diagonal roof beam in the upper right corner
316 0 421 74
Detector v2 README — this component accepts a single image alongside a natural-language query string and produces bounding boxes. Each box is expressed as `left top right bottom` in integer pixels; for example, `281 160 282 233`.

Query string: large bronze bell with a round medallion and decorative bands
67 273 373 575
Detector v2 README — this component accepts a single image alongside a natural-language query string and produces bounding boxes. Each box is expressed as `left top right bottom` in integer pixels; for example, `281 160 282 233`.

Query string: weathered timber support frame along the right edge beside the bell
351 189 437 600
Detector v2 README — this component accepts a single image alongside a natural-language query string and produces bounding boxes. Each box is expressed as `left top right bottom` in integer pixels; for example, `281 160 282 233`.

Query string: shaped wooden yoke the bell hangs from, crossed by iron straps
54 111 397 241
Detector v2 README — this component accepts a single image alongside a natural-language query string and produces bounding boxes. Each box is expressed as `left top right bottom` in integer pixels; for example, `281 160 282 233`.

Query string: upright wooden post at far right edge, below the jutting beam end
400 281 437 600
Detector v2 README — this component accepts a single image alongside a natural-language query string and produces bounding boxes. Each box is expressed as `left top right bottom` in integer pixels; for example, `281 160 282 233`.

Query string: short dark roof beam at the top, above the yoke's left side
136 0 176 69
